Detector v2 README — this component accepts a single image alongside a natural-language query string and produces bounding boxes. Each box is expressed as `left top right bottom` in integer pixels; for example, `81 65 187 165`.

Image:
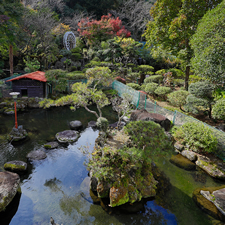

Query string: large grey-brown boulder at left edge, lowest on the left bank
0 171 20 212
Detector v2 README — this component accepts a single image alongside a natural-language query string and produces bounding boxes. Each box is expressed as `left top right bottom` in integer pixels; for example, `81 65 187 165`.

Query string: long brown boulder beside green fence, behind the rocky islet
130 109 172 131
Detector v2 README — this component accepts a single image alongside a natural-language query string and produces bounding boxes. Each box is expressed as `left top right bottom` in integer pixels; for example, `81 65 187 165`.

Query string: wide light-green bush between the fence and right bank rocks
172 122 218 153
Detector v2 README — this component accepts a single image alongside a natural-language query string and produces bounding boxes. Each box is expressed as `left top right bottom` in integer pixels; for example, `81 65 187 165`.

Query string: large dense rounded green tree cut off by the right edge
190 1 225 84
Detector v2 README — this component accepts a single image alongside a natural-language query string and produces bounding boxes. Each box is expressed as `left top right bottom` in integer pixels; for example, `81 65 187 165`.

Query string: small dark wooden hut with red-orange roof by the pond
7 71 49 98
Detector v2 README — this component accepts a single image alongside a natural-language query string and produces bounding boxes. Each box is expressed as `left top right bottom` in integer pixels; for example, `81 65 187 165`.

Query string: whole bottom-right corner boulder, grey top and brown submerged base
192 185 225 222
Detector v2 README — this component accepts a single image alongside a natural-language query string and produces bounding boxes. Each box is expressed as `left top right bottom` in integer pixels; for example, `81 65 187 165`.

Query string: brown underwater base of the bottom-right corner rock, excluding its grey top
192 185 225 221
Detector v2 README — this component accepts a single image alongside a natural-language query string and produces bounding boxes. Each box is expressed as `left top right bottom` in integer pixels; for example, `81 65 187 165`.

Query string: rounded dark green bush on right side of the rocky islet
124 121 171 162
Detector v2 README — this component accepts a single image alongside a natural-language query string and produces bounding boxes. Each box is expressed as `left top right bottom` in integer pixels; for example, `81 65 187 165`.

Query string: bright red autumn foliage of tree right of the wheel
78 14 131 44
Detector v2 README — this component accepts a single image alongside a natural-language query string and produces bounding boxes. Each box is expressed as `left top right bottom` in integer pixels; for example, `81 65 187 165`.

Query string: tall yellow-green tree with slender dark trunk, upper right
144 0 222 90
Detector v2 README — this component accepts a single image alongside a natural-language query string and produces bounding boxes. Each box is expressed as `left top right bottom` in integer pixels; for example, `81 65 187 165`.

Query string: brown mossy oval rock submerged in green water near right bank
170 154 196 170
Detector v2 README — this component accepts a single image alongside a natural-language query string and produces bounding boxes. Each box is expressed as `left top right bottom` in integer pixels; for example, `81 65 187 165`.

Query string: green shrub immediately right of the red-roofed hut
45 69 67 92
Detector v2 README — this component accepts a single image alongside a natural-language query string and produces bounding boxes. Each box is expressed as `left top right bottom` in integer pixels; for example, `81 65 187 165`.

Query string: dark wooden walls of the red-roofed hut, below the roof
12 79 45 98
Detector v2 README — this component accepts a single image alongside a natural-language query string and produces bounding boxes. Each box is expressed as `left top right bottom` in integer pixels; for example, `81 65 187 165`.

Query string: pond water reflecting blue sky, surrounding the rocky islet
0 107 224 225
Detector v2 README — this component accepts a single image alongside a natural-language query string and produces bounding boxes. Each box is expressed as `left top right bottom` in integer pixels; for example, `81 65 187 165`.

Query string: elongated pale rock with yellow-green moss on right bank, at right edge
195 155 225 180
